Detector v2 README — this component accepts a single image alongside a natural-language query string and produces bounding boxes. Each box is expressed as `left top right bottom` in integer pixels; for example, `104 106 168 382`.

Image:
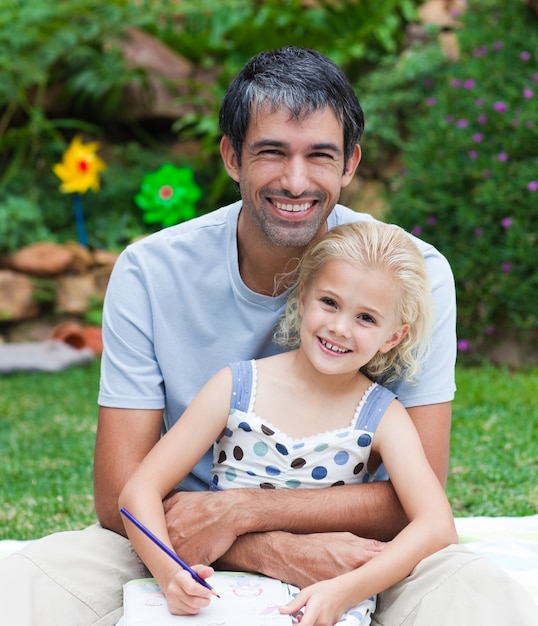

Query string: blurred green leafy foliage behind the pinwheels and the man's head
0 0 419 248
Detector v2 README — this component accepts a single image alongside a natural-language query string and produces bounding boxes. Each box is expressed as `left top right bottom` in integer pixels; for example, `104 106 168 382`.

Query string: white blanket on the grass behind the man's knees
0 514 538 605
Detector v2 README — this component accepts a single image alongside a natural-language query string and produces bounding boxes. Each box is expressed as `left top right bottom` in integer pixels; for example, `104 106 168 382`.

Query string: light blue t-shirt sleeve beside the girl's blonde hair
388 246 456 408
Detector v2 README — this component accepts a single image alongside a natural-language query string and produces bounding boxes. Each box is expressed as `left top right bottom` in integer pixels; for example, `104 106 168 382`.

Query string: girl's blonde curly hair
275 221 433 384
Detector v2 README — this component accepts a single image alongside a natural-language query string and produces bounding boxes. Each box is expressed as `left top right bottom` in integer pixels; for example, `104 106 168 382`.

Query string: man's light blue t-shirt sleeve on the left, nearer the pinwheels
98 248 165 409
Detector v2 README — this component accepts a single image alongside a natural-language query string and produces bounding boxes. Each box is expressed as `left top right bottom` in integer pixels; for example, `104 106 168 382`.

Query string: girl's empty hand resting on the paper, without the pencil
279 579 353 626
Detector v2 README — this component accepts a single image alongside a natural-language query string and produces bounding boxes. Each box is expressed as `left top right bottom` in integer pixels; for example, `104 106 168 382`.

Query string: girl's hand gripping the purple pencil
163 565 214 615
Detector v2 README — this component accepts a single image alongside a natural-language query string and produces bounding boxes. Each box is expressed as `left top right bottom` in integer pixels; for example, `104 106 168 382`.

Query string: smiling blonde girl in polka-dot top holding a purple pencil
120 222 457 626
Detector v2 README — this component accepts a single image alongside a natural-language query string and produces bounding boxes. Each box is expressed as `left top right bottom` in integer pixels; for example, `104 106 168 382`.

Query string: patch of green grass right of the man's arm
447 367 538 517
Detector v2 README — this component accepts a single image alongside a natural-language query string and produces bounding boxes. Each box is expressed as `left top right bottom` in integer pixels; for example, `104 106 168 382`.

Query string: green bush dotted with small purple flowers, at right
365 0 538 355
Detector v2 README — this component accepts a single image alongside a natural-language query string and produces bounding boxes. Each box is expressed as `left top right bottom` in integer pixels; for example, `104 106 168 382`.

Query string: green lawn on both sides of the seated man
0 361 538 539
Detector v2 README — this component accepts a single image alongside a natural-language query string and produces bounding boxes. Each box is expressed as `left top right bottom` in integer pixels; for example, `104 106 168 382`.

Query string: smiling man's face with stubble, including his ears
223 108 360 248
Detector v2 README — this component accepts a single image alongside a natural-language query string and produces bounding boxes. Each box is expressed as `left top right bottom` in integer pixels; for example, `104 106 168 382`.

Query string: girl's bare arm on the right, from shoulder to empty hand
282 401 458 626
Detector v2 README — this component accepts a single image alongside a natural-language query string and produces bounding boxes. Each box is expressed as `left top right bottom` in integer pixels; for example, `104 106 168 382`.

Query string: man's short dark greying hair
219 46 364 163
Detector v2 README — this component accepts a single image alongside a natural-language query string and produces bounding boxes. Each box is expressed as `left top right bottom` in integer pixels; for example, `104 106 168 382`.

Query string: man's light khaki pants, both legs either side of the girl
0 525 538 626
